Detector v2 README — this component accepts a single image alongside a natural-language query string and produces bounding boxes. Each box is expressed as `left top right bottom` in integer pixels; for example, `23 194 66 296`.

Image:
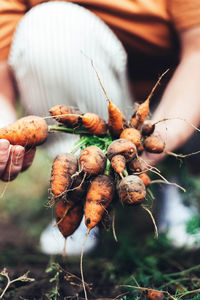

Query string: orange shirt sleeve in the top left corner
0 0 27 61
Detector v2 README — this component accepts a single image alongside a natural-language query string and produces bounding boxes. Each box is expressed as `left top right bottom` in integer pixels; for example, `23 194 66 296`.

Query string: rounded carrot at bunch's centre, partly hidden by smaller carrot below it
107 139 136 161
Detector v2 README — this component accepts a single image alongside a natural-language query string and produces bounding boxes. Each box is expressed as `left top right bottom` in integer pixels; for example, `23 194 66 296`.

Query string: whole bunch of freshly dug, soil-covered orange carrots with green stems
0 69 169 300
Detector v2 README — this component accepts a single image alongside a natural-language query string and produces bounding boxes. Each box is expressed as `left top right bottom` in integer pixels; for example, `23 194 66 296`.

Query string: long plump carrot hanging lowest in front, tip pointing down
84 175 114 230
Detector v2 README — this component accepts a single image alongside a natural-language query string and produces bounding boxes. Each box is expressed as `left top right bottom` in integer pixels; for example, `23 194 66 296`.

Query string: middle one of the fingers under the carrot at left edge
1 145 25 181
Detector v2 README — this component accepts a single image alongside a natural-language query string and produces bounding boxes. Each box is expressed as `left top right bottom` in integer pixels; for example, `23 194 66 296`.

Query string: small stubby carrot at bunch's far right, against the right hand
144 135 165 153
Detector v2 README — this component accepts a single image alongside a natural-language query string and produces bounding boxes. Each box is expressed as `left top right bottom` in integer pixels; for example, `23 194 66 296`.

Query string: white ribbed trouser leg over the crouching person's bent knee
9 2 132 156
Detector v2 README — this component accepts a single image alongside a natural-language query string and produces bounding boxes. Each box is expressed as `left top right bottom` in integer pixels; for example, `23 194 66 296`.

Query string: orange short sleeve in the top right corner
167 0 200 31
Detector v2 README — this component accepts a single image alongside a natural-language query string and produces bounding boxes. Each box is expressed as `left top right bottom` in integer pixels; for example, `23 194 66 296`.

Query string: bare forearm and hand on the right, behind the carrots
142 26 200 165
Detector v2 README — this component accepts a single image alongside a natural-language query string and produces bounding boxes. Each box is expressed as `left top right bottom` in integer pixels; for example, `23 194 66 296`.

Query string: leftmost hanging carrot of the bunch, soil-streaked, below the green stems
51 153 78 198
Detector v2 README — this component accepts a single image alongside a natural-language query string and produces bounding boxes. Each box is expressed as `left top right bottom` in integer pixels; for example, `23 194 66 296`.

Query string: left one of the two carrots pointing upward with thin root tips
108 99 127 137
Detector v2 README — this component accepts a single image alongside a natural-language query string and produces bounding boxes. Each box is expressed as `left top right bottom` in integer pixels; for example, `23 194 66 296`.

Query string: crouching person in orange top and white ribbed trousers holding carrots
0 0 200 252
